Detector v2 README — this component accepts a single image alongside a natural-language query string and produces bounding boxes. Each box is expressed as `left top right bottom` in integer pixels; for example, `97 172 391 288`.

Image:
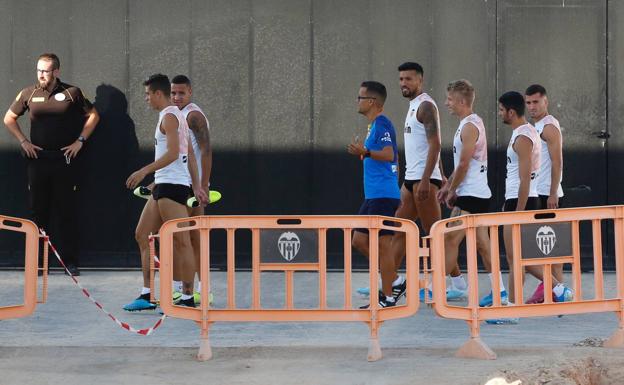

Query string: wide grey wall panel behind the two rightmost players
498 0 607 205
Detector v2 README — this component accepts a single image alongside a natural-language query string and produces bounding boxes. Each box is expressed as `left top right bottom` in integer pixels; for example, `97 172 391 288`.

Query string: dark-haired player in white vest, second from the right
498 91 571 302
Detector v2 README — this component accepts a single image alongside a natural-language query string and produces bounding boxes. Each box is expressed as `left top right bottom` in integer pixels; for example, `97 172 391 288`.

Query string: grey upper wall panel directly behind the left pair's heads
127 0 192 149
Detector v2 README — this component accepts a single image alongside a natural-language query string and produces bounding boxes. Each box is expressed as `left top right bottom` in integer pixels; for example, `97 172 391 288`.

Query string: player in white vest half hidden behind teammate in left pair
171 75 212 304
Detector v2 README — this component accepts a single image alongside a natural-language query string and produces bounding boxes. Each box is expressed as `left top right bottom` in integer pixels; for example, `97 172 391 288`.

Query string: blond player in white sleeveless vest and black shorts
438 79 507 304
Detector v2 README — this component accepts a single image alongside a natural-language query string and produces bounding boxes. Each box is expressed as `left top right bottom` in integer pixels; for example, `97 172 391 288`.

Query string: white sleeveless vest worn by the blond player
453 114 492 199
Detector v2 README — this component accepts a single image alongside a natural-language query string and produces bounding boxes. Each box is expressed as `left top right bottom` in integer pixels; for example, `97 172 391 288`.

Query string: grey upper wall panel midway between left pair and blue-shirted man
251 0 311 150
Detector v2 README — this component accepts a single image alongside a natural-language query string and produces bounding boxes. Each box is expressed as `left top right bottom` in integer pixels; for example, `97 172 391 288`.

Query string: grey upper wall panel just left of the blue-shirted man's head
312 1 371 149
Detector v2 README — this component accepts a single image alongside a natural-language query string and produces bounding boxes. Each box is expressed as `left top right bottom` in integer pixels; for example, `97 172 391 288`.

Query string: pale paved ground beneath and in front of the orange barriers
0 271 624 385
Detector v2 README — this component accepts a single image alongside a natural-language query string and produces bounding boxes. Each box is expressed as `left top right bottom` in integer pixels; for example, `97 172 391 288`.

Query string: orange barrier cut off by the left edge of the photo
0 215 48 320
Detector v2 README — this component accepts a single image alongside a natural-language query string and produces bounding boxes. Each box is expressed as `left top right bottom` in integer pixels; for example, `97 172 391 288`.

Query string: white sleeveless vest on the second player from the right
505 123 542 200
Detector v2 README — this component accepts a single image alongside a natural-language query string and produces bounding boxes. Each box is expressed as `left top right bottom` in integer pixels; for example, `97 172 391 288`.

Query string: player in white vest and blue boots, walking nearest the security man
124 74 206 311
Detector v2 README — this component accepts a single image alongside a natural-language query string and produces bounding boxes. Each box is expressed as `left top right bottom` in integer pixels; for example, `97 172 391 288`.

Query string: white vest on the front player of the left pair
154 106 191 186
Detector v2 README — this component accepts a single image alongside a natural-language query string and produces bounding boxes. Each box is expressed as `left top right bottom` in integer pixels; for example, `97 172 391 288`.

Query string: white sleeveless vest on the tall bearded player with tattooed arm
403 93 442 180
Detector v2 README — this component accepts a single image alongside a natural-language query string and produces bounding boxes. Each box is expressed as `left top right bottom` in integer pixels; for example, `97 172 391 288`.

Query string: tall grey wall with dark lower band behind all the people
0 0 624 265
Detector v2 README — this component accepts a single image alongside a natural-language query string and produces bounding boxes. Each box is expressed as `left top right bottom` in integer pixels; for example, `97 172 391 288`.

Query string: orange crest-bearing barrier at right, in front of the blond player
431 206 624 359
